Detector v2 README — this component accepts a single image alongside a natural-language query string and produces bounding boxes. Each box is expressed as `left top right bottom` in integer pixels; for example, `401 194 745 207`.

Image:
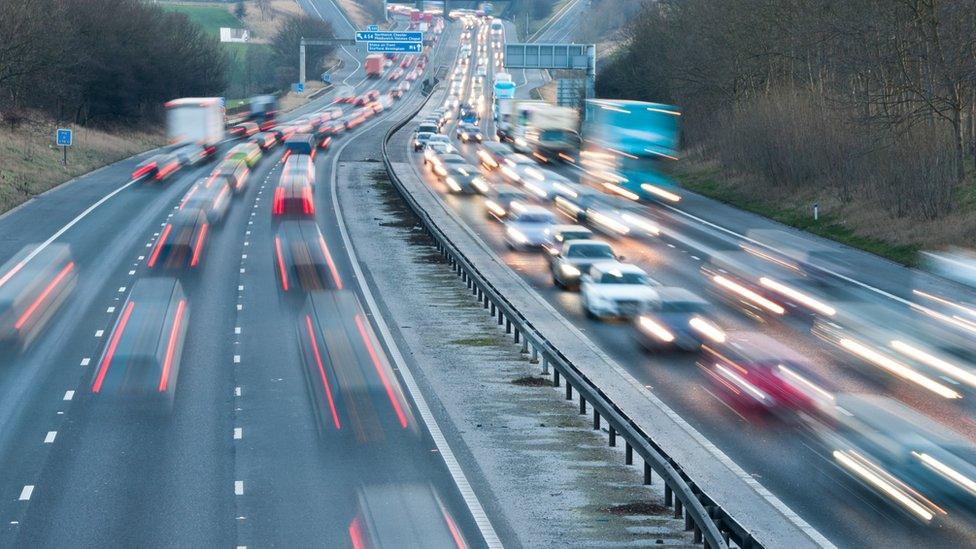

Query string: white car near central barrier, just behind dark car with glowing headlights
580 261 660 318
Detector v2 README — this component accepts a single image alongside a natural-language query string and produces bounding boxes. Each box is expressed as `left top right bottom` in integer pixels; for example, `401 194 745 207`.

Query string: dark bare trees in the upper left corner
0 0 228 124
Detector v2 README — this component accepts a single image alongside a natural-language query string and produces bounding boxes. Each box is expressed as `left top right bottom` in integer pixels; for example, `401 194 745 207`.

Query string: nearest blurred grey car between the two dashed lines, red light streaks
92 277 190 409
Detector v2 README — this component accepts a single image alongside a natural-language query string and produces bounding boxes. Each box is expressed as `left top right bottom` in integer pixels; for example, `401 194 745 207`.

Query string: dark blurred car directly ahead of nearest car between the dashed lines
146 208 210 270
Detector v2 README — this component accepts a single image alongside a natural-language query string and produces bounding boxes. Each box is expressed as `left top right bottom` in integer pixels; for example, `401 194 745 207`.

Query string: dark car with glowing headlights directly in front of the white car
634 287 725 351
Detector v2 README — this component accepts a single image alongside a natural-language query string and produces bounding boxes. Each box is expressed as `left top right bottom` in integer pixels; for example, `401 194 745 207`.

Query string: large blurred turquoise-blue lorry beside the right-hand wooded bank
581 99 681 199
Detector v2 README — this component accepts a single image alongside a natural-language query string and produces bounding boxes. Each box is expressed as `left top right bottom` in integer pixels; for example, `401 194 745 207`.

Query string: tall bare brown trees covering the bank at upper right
597 0 976 223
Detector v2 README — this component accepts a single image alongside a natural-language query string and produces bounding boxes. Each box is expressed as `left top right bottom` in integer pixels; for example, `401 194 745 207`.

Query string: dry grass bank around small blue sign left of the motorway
0 118 166 213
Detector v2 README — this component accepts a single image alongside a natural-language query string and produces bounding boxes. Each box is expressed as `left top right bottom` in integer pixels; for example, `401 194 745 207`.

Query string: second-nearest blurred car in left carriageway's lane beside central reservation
298 290 419 440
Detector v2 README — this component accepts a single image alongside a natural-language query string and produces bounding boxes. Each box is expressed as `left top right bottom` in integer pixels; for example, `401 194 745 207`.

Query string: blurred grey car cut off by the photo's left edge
0 243 78 349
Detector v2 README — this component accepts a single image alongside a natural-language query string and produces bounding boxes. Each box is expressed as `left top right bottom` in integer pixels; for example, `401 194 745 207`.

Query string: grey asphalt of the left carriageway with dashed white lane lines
0 9 499 547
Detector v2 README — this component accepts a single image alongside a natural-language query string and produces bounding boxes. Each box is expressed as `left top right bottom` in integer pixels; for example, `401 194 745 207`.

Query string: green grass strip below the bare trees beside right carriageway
675 165 919 267
